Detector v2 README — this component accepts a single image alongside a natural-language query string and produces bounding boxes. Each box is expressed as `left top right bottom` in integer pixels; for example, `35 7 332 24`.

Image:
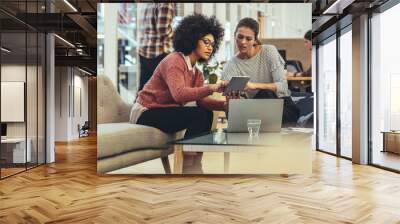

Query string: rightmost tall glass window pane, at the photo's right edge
370 4 400 171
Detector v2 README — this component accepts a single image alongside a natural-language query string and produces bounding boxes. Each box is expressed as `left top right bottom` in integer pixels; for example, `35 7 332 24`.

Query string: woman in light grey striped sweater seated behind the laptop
222 18 299 125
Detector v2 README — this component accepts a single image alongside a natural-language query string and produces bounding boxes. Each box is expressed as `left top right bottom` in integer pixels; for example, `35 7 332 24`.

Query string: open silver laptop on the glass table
227 99 283 132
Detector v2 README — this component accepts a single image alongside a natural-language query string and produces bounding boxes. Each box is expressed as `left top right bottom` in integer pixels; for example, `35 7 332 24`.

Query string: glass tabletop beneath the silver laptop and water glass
172 129 312 146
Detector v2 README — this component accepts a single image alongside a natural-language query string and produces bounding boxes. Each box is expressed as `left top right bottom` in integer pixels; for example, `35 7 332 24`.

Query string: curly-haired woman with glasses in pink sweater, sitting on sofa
130 14 228 173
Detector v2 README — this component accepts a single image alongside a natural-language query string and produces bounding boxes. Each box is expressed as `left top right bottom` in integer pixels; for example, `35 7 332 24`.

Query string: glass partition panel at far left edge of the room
0 32 30 177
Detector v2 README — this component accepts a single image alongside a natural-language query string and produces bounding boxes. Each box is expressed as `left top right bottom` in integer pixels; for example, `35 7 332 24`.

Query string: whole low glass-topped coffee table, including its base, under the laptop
173 128 313 174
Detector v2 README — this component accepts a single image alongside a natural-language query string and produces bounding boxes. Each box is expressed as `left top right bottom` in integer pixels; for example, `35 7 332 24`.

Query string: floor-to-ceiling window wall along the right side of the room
313 1 400 171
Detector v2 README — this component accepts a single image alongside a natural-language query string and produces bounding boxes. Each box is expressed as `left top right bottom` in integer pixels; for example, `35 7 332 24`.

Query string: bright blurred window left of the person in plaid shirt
97 3 138 103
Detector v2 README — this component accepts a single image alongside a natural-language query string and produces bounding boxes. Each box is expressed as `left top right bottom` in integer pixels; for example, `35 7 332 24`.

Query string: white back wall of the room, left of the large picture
55 67 89 141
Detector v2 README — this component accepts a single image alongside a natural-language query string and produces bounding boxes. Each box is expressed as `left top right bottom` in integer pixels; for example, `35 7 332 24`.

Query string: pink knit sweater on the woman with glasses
137 52 224 110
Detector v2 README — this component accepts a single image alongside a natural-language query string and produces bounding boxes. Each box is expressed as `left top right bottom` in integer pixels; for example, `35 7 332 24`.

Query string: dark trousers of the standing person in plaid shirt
139 53 168 91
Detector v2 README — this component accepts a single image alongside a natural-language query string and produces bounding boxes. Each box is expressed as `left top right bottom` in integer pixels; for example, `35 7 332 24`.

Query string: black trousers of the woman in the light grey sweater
254 90 300 127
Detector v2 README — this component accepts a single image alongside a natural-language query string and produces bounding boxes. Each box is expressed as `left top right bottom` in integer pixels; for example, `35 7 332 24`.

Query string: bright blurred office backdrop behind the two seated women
97 3 311 103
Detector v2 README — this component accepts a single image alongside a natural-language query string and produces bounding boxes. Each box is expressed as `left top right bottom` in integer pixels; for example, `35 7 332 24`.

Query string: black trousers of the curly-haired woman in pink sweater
137 107 213 138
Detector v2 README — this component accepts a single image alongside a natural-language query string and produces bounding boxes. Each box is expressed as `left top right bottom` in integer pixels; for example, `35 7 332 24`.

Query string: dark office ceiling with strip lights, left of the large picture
0 0 98 73
